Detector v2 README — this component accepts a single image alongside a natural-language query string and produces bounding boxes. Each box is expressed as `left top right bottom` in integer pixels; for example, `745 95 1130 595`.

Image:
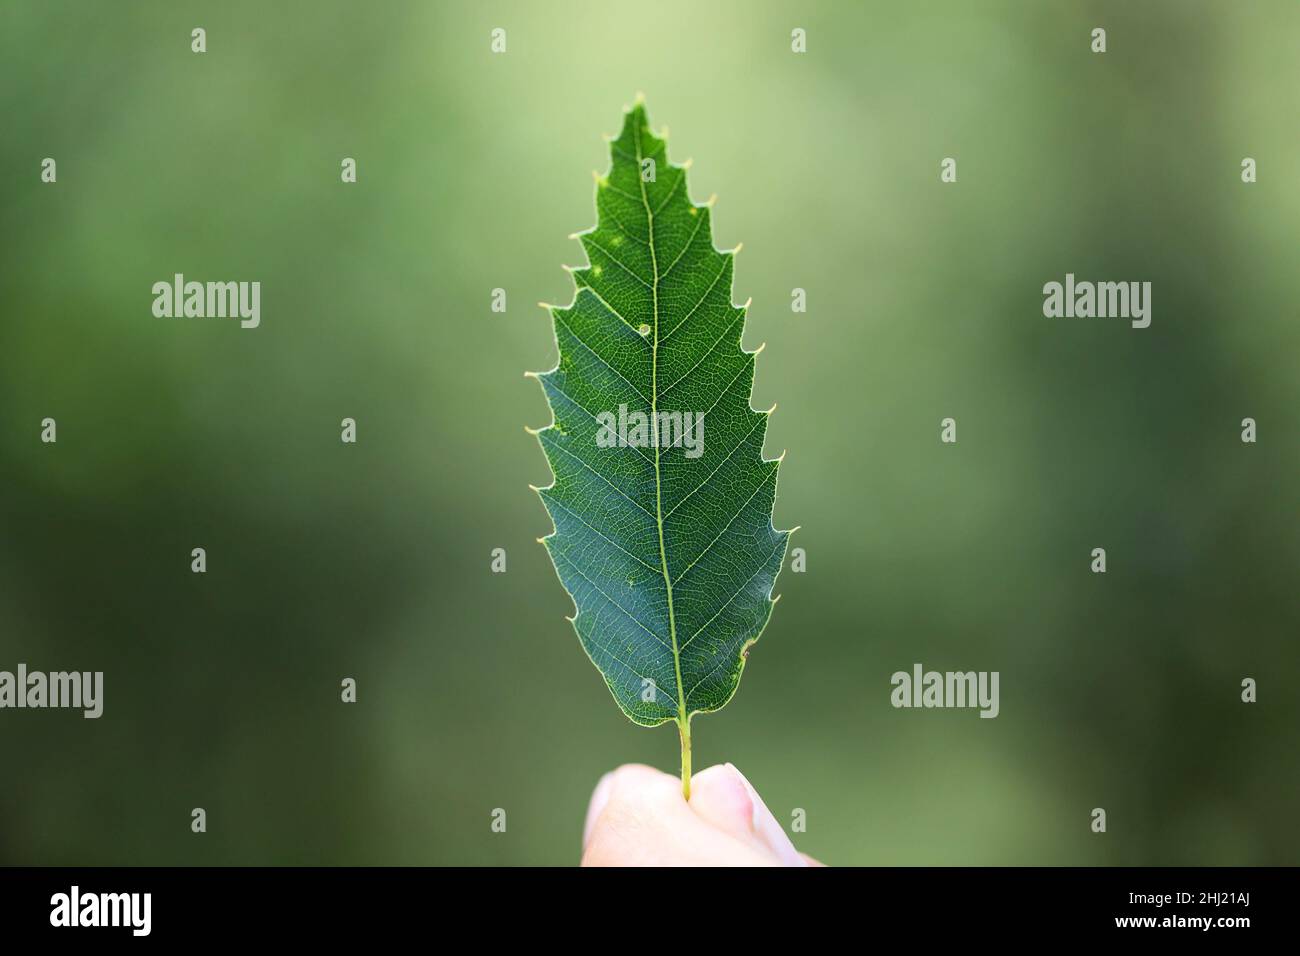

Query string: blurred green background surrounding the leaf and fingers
0 0 1300 865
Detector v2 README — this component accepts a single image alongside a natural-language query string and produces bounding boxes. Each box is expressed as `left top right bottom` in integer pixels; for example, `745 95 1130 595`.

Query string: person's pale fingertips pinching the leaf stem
582 763 822 866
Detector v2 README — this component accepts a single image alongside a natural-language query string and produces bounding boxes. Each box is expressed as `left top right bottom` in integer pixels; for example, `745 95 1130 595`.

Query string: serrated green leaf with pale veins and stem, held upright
530 99 790 796
